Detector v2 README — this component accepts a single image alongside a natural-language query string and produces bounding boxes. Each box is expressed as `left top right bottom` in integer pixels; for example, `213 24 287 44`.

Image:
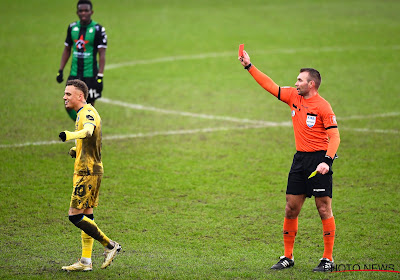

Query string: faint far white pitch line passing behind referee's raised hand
106 45 400 70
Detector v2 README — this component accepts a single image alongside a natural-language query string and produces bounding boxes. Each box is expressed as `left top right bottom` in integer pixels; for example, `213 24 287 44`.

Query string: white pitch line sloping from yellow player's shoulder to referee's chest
97 97 292 126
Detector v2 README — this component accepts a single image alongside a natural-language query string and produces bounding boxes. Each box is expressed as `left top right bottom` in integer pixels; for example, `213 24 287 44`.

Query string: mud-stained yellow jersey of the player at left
74 104 103 175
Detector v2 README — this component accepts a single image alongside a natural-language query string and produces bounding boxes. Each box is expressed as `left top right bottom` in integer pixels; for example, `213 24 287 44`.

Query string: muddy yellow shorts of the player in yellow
70 174 103 209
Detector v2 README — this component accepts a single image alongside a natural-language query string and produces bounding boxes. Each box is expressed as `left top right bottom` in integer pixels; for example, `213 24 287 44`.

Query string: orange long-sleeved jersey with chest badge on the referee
249 65 340 159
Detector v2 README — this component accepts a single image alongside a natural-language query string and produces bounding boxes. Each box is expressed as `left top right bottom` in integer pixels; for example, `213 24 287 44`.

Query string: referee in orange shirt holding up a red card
239 51 340 272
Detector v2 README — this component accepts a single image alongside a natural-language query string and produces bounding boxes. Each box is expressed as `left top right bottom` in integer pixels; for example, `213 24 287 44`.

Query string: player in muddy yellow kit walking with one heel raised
59 80 121 271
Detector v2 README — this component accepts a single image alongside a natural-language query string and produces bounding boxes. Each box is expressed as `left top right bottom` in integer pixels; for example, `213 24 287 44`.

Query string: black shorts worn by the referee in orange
286 151 333 198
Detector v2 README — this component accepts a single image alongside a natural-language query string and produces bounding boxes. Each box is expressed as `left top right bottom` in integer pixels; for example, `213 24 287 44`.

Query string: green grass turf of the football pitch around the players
0 0 400 279
